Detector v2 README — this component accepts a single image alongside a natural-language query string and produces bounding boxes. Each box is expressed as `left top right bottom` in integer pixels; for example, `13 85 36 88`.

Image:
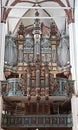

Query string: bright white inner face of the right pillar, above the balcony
69 23 78 93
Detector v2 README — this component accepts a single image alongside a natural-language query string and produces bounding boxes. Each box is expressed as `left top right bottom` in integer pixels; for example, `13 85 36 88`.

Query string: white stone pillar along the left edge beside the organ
0 23 6 130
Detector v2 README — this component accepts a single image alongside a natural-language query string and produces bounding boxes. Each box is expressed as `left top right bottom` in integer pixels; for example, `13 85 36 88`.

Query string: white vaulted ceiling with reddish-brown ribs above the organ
1 0 75 33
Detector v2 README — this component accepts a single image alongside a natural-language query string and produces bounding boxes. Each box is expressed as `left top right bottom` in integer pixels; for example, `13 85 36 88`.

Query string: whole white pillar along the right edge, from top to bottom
69 0 78 130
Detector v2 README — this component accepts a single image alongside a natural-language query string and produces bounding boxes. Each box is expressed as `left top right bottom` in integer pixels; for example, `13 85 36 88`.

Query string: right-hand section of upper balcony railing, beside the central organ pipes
50 78 74 96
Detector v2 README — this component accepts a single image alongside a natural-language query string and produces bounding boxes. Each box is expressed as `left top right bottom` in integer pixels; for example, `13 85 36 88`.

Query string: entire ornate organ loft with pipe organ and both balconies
1 11 74 129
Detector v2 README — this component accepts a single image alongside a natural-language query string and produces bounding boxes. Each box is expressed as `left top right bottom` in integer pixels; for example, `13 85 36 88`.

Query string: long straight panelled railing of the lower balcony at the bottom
2 114 72 127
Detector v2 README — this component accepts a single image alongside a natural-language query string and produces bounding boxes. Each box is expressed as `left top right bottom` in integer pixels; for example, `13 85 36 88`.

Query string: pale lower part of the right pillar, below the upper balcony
71 95 78 130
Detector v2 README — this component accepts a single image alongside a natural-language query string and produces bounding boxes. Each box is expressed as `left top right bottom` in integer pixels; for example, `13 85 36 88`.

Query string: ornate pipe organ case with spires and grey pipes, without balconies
4 12 70 97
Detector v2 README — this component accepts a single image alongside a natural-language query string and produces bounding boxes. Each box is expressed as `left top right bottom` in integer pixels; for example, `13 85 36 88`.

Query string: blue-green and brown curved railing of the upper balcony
1 78 74 97
